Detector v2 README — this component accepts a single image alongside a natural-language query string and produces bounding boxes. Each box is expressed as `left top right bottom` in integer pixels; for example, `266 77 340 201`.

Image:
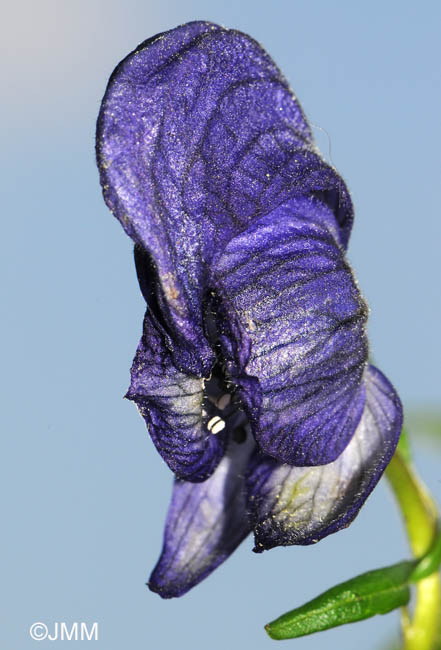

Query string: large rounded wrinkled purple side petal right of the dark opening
213 198 368 466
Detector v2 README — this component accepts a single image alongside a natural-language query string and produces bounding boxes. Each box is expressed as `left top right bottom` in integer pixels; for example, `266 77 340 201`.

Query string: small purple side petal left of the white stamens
126 312 225 481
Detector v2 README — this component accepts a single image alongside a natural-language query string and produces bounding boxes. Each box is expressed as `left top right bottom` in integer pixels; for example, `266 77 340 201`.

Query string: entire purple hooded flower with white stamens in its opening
97 22 402 597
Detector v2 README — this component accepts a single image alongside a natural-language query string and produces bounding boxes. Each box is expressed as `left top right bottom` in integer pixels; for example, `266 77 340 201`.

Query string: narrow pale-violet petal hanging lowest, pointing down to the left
148 437 254 598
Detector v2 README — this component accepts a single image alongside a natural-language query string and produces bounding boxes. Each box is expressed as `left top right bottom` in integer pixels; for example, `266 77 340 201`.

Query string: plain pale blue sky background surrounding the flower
0 0 441 650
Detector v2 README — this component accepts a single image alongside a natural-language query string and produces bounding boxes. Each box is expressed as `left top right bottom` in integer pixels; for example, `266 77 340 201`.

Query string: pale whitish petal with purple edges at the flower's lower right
248 366 402 552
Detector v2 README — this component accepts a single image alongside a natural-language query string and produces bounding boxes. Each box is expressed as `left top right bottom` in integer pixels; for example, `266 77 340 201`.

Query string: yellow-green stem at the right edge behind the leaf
386 432 441 650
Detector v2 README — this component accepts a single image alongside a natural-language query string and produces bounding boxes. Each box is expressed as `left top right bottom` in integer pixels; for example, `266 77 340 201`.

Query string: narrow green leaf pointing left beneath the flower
265 561 416 639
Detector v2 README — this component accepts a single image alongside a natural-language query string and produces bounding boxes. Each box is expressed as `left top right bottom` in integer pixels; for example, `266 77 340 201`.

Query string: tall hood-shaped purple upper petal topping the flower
97 22 352 374
